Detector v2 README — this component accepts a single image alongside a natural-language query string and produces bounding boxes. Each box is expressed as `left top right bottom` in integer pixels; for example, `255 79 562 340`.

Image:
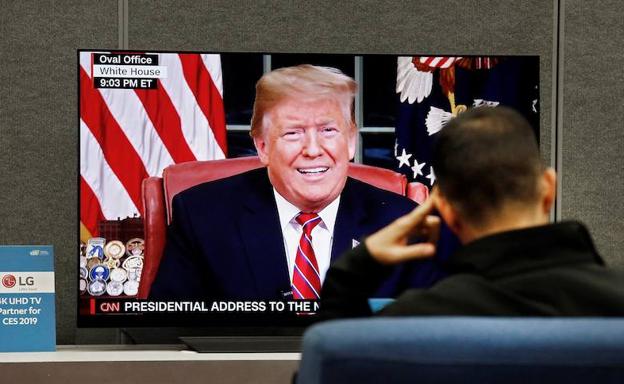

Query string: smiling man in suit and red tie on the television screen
150 65 444 300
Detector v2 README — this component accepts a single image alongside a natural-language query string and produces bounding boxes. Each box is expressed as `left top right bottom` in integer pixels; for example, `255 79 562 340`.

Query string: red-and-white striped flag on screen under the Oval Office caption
79 52 227 240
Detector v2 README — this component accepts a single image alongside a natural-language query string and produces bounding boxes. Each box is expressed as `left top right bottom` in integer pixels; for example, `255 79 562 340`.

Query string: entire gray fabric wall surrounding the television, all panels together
0 0 624 344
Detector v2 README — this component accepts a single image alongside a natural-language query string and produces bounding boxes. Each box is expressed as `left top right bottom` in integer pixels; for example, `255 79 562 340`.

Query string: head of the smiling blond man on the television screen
251 65 357 212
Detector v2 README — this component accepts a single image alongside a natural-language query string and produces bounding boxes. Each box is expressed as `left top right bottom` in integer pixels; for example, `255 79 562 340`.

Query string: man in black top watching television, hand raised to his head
321 107 624 318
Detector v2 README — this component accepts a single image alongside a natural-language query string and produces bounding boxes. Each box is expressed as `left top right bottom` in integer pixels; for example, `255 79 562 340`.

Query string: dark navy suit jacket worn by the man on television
150 168 438 300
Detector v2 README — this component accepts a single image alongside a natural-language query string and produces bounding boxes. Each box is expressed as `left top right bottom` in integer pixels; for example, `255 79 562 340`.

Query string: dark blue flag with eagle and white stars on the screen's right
394 56 539 285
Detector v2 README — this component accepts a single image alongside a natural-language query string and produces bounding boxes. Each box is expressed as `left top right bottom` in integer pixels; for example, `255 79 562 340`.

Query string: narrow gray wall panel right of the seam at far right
559 0 624 268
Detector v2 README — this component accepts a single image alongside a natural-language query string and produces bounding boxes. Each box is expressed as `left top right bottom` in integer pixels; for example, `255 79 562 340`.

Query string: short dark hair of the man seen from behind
433 107 543 225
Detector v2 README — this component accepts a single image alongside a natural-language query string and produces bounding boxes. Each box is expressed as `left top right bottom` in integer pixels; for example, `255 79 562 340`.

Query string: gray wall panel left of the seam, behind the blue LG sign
0 0 119 344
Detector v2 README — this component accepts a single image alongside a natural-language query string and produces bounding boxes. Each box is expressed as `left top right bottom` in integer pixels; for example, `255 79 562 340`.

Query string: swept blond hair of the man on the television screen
250 64 357 137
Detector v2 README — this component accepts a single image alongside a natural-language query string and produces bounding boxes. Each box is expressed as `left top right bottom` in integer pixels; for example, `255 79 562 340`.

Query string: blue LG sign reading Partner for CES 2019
0 245 56 352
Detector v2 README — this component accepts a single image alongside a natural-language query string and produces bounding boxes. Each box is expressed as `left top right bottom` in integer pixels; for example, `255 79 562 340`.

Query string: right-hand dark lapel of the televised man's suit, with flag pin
331 178 367 262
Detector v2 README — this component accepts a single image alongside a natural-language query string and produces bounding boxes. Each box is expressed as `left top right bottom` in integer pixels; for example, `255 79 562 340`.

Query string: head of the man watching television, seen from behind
433 107 556 243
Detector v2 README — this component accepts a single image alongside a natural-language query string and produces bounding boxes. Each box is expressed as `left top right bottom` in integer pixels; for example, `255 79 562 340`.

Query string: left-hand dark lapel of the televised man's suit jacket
239 168 290 298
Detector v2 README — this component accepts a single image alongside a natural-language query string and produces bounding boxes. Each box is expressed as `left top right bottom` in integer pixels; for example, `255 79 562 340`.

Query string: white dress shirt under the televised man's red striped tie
273 188 340 284
